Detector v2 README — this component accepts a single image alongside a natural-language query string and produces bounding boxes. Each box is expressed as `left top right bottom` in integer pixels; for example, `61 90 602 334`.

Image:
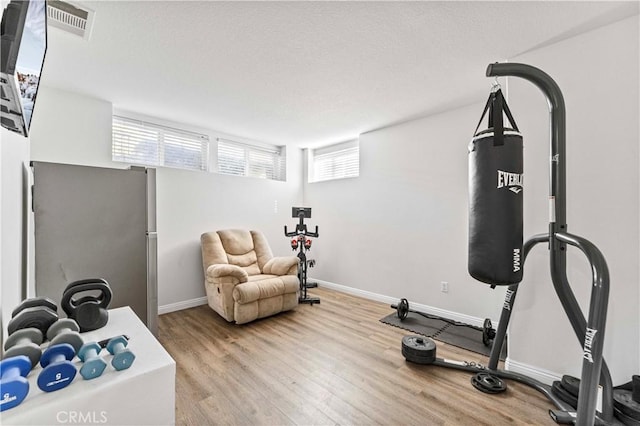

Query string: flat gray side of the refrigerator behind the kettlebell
33 162 147 324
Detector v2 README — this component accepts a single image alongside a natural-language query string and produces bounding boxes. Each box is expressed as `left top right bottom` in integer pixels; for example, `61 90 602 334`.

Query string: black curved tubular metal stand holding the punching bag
403 63 614 426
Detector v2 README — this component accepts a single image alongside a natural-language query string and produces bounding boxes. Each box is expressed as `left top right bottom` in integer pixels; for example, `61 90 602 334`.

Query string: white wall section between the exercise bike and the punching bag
305 101 504 318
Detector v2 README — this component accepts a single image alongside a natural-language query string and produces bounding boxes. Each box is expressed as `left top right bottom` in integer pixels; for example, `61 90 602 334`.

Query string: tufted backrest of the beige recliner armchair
200 229 273 275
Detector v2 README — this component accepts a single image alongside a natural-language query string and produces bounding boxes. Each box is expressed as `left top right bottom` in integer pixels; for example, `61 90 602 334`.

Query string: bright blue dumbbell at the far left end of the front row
0 355 31 411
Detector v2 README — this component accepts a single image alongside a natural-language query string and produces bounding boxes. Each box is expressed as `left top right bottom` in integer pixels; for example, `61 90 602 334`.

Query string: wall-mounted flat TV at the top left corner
0 0 47 136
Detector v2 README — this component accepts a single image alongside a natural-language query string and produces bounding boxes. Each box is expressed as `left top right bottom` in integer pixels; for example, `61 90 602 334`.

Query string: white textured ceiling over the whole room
42 0 638 146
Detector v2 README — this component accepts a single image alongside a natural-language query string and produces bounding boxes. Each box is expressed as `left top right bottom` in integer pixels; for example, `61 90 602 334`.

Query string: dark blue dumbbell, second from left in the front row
38 343 77 392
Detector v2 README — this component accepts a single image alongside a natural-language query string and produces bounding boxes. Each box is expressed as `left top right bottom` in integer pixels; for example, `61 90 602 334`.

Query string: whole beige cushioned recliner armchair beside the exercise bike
200 229 300 324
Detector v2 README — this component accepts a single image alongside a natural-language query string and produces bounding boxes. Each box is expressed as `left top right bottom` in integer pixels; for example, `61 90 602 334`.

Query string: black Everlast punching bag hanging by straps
468 89 523 285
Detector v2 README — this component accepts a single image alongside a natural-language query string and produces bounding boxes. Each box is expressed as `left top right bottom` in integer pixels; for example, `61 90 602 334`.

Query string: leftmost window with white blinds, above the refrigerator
111 115 209 171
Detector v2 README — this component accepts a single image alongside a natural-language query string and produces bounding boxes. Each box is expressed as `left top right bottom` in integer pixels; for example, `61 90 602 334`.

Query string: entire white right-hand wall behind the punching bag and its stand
304 16 640 383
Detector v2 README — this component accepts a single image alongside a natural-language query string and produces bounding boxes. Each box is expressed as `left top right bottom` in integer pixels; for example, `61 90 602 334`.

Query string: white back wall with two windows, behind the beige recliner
31 86 302 312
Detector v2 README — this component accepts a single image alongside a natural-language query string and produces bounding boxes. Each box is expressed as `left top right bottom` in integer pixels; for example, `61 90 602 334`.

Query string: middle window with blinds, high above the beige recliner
218 138 287 181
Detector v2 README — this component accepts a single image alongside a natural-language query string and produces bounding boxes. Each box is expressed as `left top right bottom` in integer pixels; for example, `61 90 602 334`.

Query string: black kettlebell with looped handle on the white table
60 278 113 333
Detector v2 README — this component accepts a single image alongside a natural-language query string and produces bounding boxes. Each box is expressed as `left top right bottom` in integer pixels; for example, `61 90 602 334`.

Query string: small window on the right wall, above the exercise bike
309 139 360 182
